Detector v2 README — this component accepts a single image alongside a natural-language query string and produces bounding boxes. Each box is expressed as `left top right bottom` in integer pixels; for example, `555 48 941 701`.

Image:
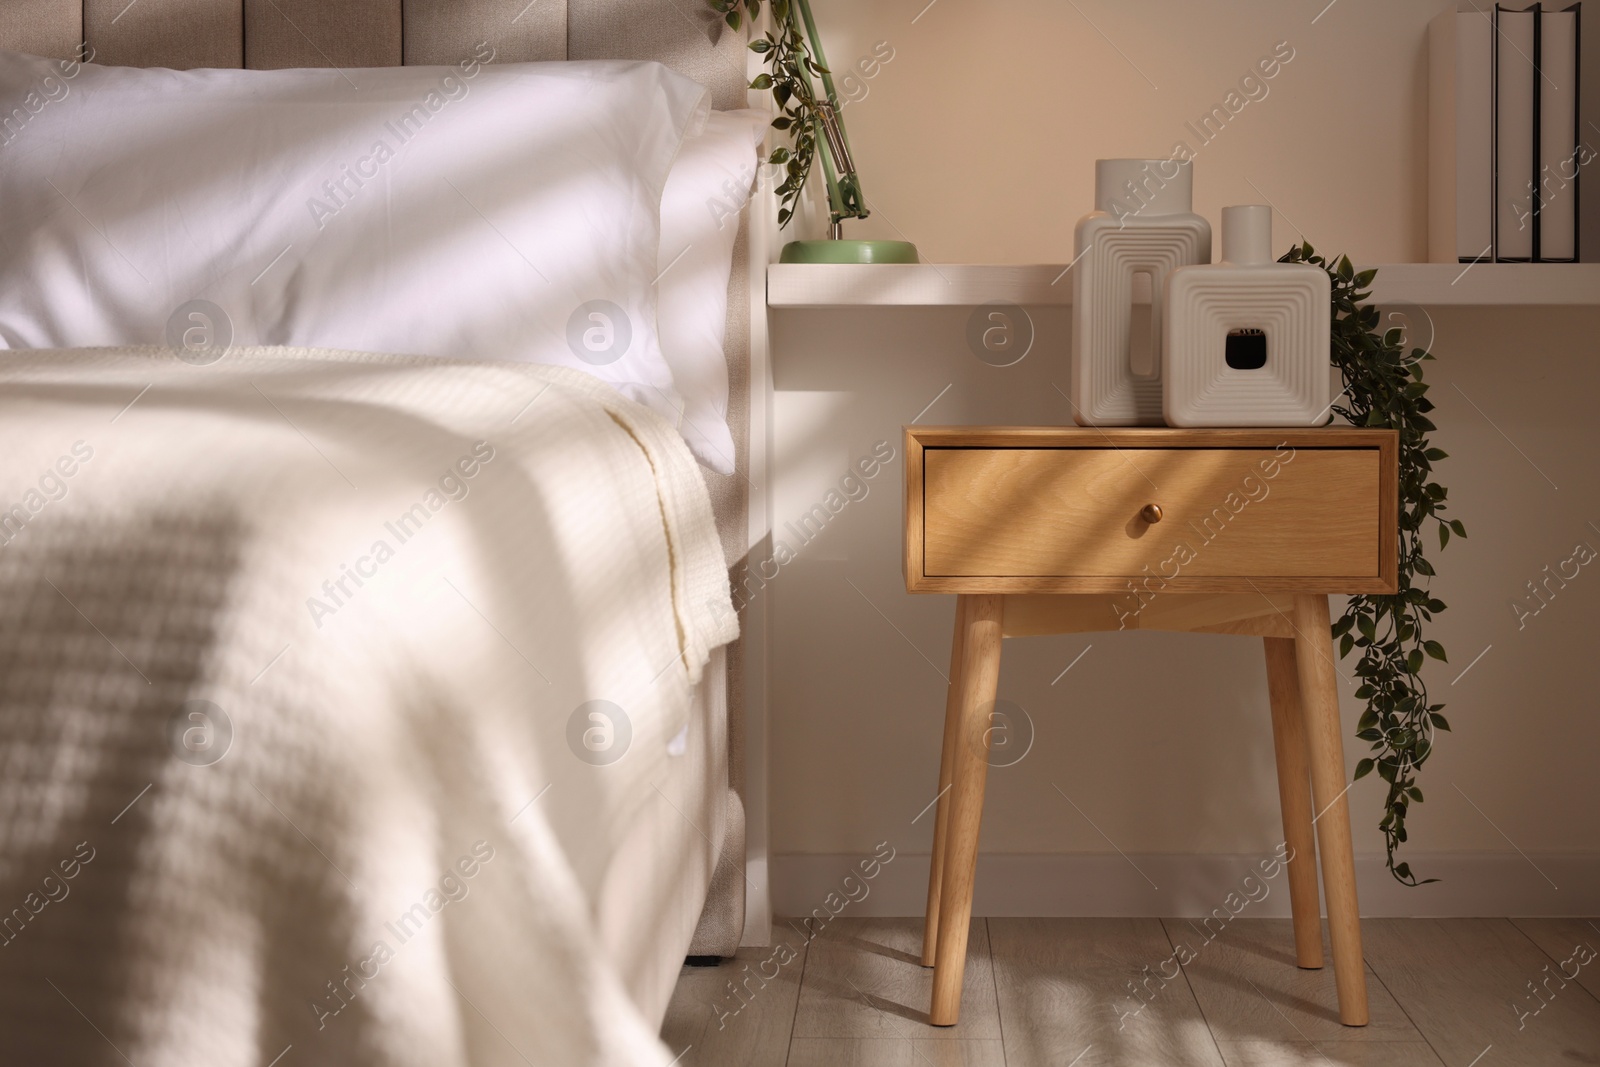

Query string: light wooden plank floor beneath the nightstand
661 917 1600 1067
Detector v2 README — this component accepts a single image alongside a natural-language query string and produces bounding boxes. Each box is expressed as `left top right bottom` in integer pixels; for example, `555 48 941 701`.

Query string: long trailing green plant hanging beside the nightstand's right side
1280 243 1467 886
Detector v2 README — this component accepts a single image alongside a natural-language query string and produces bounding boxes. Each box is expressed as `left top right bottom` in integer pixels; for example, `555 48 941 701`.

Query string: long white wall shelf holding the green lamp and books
766 262 1600 307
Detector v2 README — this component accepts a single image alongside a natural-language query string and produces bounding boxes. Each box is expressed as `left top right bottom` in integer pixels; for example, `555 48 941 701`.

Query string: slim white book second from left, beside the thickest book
1494 5 1538 262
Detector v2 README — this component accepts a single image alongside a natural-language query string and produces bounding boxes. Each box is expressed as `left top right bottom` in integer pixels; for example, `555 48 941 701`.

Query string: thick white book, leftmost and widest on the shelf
1427 10 1494 262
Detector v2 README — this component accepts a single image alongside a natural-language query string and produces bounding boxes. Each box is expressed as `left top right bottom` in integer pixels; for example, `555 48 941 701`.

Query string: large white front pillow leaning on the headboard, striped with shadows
0 45 709 421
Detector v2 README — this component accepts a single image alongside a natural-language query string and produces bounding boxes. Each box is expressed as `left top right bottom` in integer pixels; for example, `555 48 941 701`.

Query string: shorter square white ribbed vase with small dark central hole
1162 205 1331 426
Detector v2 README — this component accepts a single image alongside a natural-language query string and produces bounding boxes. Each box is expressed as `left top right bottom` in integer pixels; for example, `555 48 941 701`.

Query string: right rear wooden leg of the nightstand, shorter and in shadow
1264 637 1322 968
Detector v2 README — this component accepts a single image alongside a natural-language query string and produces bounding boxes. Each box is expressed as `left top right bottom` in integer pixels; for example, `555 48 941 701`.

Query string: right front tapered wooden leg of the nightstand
1294 595 1366 1027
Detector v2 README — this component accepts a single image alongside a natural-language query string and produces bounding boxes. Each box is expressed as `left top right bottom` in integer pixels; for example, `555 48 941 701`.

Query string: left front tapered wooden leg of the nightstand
928 595 1005 1027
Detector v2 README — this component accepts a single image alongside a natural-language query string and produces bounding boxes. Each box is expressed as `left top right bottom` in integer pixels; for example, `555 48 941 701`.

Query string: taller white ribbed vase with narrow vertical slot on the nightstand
1072 160 1211 426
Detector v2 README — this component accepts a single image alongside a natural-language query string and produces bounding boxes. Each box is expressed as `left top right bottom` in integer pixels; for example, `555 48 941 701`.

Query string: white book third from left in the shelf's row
1539 10 1579 262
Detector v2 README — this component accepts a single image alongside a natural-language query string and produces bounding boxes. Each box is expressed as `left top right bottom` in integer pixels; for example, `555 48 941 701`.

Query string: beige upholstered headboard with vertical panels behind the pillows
0 0 760 955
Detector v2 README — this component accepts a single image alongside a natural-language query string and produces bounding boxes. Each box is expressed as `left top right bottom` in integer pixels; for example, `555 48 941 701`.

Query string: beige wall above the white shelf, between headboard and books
813 0 1445 262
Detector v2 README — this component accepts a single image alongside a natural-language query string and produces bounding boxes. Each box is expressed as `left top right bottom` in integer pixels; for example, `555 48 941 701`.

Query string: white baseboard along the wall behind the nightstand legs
771 851 1600 918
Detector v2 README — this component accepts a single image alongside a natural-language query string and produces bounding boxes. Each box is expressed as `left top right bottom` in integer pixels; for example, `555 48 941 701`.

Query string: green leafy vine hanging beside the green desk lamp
706 0 844 227
